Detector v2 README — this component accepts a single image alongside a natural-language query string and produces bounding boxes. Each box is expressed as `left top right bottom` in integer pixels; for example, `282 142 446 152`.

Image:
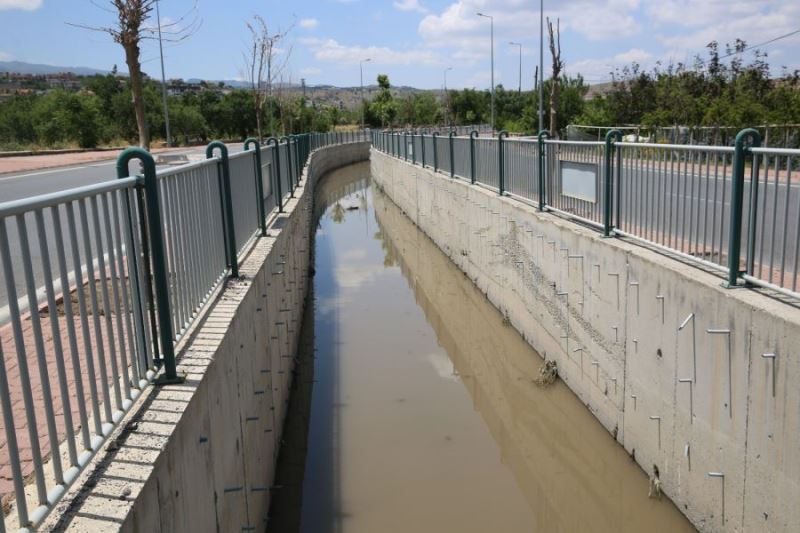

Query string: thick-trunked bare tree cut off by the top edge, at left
71 0 201 150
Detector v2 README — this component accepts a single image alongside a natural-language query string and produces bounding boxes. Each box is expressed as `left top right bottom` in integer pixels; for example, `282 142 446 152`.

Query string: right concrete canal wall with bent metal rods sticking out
371 150 800 532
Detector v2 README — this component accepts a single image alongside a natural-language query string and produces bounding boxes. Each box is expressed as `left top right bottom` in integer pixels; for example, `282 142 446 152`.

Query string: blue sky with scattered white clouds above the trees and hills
0 0 800 88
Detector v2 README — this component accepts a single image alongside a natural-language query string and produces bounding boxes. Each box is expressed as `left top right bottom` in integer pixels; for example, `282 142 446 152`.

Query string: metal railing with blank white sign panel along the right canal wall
373 129 800 297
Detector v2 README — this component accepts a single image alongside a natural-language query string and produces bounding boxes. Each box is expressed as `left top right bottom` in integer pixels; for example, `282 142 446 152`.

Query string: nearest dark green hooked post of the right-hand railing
723 128 761 288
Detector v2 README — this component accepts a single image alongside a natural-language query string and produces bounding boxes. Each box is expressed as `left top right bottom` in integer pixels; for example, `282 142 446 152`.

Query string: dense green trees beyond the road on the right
577 39 800 128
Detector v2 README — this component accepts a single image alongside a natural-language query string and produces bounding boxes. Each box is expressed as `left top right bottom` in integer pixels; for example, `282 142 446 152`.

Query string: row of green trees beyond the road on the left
0 75 356 150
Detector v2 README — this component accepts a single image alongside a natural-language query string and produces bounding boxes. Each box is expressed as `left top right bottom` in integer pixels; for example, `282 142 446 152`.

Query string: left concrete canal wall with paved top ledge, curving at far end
42 143 369 533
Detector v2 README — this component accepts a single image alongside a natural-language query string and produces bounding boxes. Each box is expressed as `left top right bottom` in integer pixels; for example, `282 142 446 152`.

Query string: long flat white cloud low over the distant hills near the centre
300 38 440 66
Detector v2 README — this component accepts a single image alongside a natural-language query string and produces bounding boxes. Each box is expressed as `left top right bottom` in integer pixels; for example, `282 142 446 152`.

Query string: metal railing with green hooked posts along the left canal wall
0 131 370 531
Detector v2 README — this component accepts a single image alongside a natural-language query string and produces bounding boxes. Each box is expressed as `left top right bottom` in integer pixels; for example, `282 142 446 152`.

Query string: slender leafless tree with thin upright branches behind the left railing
244 15 294 139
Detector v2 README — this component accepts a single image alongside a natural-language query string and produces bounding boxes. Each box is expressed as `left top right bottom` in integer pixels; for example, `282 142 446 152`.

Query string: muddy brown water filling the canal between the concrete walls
268 164 694 533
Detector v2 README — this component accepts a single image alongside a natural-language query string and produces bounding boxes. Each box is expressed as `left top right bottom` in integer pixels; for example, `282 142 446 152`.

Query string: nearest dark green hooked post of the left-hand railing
117 148 186 385
